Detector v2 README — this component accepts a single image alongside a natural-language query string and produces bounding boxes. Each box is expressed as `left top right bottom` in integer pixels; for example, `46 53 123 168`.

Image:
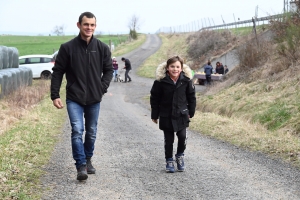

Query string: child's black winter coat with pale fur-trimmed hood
150 63 196 132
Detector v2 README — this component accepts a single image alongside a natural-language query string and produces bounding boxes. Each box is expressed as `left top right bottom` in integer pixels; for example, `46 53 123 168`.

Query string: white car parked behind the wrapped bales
19 55 55 79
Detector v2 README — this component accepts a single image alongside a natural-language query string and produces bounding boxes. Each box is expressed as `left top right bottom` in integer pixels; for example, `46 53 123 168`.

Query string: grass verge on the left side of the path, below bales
0 81 66 199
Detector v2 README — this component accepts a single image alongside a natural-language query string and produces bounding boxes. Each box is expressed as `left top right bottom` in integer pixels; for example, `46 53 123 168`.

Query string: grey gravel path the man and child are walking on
42 35 300 200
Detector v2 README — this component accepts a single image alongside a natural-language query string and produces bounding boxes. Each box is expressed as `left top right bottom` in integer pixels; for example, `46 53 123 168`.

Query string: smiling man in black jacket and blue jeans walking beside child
51 12 113 180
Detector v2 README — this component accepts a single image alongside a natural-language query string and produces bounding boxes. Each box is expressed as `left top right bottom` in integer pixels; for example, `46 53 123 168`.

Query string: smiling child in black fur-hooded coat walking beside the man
150 56 196 173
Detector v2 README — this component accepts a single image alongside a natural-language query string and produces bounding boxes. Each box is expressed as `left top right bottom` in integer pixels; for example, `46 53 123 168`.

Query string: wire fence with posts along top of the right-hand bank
156 14 283 33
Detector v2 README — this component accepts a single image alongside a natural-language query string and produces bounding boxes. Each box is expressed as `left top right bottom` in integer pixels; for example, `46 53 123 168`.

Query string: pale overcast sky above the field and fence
0 0 284 35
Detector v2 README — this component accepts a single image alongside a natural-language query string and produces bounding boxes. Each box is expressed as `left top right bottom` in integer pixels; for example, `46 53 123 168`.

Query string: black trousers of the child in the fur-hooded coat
164 128 187 159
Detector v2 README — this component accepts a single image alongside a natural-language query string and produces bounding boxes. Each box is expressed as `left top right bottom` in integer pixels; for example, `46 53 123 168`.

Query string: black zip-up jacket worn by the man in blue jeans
51 34 113 105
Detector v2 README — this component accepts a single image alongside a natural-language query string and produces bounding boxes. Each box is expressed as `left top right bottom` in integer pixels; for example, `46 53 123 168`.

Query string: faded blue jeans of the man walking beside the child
66 99 100 168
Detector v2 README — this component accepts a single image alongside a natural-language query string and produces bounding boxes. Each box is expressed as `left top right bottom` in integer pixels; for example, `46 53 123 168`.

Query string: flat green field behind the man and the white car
0 35 128 56
